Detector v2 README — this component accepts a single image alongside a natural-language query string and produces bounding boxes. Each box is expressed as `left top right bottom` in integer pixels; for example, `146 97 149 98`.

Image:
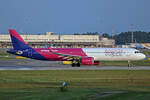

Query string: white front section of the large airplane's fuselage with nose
82 48 146 61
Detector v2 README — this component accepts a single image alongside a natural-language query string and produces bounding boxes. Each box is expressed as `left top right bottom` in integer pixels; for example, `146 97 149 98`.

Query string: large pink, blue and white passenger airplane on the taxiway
7 29 146 67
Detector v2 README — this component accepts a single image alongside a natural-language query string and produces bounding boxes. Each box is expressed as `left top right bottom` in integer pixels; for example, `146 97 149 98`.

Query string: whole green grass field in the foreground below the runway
0 70 150 100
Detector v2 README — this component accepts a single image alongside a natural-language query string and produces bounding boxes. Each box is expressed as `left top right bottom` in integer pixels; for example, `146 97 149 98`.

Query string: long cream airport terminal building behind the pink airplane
0 32 115 48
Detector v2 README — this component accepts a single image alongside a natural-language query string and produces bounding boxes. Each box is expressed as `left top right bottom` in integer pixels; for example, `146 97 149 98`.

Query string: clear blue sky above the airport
0 0 150 34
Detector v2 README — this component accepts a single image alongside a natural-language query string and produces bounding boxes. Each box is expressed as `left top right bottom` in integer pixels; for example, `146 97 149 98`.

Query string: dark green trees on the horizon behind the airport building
74 31 150 45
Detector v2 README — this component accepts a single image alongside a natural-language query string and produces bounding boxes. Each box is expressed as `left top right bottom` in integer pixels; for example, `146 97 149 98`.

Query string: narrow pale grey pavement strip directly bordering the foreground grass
0 66 150 70
